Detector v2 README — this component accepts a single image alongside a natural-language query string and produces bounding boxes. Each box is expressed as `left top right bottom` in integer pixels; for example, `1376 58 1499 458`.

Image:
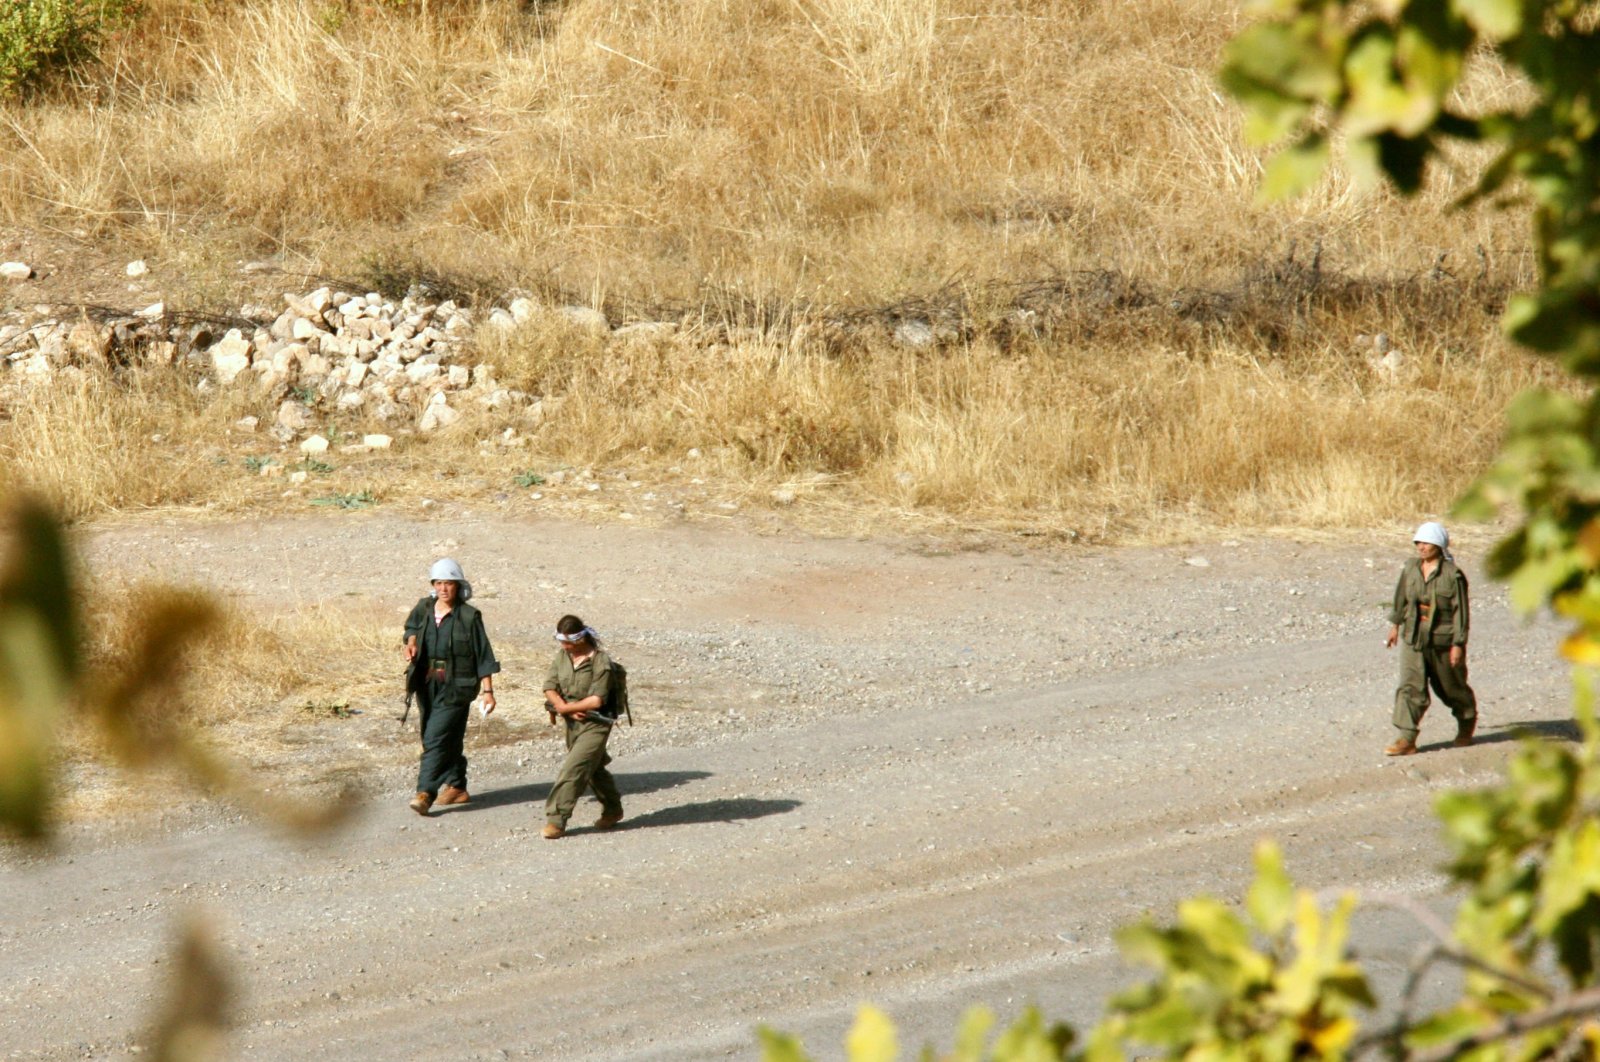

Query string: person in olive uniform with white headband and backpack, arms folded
544 616 622 841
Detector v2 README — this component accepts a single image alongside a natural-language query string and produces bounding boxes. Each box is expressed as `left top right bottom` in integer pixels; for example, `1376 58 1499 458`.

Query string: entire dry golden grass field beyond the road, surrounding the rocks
0 0 1544 541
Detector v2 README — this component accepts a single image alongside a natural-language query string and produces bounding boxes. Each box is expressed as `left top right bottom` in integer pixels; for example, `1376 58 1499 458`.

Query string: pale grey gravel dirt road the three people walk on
0 512 1570 1060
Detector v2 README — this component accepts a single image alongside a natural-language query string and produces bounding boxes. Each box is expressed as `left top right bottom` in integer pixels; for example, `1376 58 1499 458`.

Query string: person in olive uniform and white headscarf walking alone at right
1384 521 1478 757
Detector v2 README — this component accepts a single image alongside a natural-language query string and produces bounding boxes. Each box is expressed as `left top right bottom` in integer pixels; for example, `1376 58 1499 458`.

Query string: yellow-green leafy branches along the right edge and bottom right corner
762 0 1600 1062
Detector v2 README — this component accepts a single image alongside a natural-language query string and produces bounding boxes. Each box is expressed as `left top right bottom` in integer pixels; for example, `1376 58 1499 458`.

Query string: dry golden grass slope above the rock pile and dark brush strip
0 0 1522 294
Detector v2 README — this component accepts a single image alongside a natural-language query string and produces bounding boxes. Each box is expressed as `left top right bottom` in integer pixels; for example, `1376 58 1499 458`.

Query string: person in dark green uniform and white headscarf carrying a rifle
405 557 499 816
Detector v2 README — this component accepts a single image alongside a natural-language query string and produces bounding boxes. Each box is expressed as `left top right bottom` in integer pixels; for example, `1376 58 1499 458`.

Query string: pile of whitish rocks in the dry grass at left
0 288 569 441
